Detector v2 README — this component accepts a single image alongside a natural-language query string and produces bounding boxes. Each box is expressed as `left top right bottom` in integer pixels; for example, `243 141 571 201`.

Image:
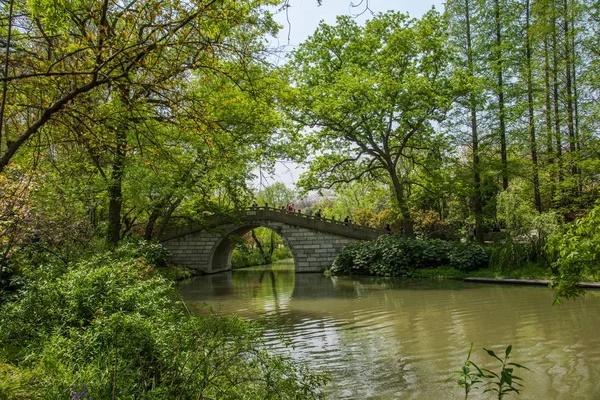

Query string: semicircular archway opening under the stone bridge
211 224 297 271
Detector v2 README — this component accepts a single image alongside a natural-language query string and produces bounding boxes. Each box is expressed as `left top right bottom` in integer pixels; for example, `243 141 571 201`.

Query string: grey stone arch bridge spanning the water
160 207 386 273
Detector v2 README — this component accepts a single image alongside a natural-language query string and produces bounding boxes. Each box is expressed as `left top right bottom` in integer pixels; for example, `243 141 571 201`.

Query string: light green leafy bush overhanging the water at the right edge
547 203 600 301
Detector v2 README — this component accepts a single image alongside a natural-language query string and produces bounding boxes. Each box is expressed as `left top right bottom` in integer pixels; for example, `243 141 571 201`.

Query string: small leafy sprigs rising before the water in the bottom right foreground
454 344 529 400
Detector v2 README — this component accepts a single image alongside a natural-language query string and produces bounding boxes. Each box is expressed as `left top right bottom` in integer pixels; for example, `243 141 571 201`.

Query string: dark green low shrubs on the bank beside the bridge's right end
330 236 488 276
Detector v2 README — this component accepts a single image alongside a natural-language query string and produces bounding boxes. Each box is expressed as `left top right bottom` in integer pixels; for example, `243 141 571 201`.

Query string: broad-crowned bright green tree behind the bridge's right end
287 10 451 235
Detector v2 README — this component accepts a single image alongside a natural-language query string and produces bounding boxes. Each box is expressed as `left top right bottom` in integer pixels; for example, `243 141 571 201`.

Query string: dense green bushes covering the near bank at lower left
0 245 324 399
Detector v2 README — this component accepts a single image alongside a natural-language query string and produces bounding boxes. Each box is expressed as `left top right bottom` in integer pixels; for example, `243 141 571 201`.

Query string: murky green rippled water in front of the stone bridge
179 262 600 399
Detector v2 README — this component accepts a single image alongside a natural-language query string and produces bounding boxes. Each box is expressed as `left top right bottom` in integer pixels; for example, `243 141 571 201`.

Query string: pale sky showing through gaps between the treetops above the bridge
253 0 443 188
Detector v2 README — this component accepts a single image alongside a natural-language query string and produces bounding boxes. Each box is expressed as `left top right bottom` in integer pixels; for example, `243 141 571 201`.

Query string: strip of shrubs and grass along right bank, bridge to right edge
325 231 600 301
